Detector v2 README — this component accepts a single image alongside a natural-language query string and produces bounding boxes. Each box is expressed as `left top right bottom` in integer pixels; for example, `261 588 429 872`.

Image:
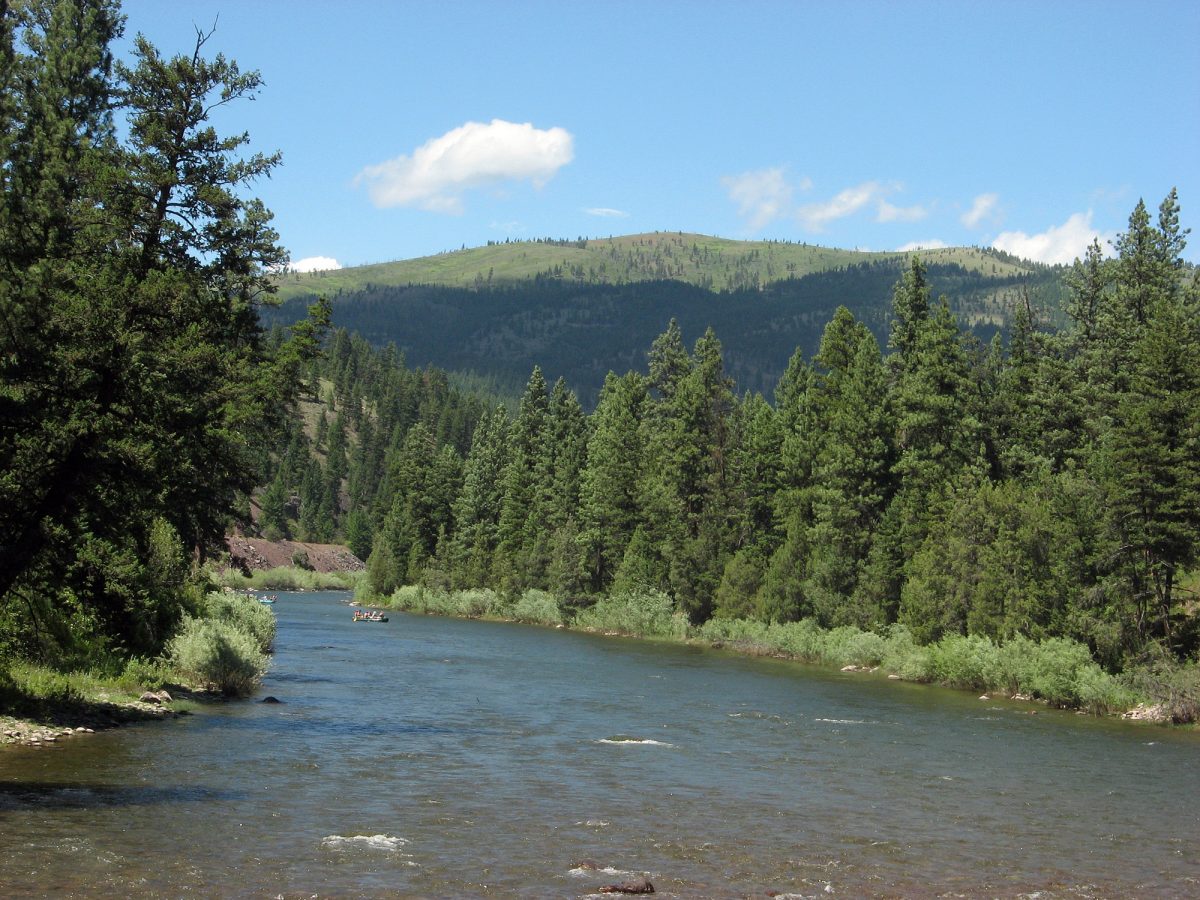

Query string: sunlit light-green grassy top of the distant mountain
278 232 1043 299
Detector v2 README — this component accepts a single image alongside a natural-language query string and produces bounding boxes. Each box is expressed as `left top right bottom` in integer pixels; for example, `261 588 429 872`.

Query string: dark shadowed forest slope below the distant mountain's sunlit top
265 257 1062 408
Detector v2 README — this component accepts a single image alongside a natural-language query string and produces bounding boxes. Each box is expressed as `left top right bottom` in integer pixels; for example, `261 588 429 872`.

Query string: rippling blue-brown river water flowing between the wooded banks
0 593 1200 898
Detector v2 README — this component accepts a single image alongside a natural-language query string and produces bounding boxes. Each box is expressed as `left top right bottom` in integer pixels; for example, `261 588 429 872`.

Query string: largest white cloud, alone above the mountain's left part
354 119 575 214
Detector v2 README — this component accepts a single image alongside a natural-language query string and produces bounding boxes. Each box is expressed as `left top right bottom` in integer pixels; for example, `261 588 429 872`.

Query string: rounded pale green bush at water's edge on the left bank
167 617 266 697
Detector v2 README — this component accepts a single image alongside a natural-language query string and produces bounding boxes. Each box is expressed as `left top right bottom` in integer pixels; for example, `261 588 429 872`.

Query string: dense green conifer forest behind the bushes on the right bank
271 192 1200 700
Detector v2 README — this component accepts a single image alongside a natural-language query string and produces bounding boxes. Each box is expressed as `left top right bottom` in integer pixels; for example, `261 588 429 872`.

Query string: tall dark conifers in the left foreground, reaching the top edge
0 0 320 656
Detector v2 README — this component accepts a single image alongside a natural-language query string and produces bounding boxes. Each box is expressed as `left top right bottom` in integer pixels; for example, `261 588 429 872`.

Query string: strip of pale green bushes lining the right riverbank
367 586 1200 725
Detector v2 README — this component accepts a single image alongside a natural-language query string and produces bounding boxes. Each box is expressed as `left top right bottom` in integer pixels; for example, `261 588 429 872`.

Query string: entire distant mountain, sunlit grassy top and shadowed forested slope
264 240 1062 404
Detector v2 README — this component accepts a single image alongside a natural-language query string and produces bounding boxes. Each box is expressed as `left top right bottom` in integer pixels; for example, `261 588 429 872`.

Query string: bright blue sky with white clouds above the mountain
124 0 1200 268
